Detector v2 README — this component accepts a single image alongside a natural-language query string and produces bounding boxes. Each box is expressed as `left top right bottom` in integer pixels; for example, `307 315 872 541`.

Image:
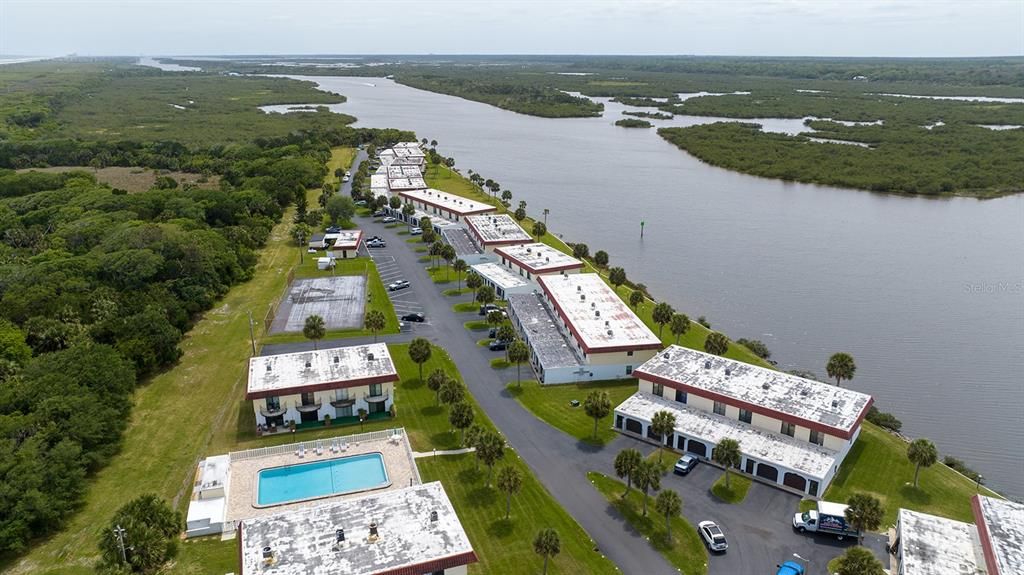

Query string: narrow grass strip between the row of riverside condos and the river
426 166 765 367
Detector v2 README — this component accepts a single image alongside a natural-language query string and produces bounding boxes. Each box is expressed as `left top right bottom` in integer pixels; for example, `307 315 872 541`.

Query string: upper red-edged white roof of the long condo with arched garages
633 346 871 434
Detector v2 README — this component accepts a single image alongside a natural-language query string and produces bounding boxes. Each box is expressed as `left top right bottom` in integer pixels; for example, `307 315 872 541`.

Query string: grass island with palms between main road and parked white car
587 472 708 575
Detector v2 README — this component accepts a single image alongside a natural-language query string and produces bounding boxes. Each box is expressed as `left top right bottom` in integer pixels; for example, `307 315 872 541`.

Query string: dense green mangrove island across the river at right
658 123 1024 196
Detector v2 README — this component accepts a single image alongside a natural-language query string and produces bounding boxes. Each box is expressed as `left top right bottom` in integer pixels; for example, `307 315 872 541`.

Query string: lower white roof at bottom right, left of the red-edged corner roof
897 508 987 575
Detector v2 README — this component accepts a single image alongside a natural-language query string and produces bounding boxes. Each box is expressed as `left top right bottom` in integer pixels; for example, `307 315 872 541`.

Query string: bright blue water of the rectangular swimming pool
256 453 388 505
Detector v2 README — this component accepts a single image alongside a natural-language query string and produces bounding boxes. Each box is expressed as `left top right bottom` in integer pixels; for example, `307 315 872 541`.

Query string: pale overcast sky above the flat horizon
0 0 1024 57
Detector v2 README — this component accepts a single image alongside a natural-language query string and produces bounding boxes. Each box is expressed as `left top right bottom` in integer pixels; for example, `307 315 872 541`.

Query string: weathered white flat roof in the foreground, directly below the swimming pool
241 481 476 575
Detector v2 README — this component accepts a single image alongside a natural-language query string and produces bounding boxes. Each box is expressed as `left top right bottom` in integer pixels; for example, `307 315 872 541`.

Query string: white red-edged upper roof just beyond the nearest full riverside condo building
537 273 662 353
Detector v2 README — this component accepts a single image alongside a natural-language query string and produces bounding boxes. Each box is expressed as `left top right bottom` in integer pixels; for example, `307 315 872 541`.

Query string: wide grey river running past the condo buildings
274 77 1024 497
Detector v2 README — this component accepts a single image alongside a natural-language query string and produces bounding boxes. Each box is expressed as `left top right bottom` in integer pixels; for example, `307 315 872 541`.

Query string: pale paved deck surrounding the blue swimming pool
225 436 419 522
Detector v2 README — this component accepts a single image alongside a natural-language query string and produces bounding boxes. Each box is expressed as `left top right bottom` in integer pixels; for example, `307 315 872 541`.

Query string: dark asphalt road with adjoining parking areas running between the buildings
263 212 885 575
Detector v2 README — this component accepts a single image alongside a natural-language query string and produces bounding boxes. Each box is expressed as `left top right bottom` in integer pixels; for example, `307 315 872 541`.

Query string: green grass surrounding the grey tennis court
260 254 398 344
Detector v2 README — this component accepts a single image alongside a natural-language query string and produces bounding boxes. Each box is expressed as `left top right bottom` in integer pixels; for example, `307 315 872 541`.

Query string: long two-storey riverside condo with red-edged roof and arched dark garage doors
614 346 872 496
